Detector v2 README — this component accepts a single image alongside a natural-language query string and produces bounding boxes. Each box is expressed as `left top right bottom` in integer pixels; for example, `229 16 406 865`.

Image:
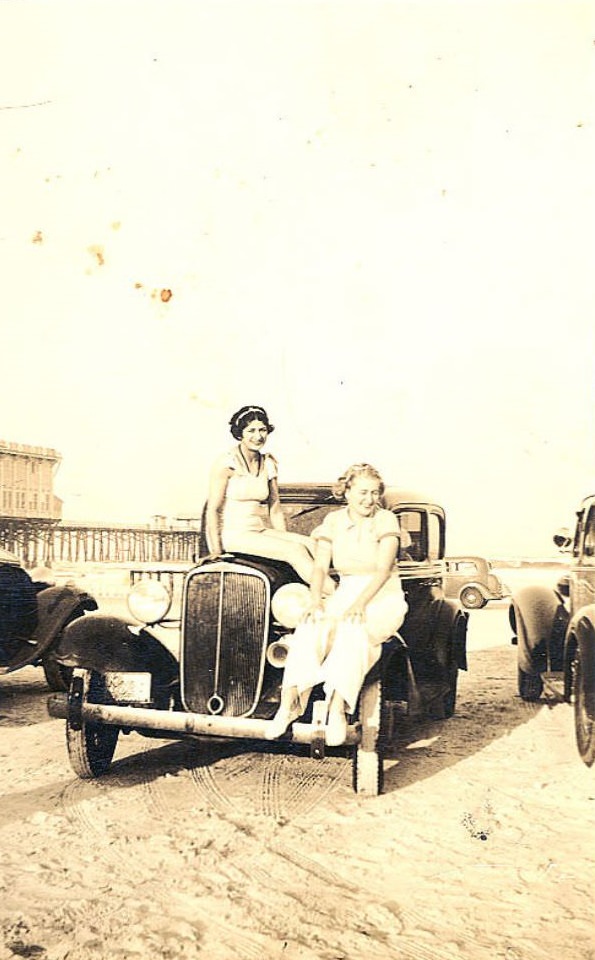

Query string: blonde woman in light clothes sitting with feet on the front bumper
268 463 407 746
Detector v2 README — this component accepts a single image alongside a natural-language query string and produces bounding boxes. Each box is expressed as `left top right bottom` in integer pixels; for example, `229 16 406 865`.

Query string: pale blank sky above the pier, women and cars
0 0 595 556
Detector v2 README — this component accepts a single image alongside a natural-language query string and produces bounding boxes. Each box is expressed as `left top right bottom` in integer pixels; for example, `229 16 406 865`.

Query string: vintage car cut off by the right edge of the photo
509 496 595 766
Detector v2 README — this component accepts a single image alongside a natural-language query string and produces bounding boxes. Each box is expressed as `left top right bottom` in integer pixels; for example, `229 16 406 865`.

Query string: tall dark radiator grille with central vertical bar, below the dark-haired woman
181 563 270 717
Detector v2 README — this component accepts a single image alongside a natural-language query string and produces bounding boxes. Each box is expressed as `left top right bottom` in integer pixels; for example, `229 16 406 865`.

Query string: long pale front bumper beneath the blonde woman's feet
47 693 361 746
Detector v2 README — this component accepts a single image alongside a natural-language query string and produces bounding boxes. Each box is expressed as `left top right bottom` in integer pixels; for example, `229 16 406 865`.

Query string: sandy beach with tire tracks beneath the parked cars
0 578 595 960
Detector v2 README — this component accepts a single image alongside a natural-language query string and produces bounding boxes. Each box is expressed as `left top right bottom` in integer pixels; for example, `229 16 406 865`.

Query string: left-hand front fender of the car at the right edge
508 585 568 675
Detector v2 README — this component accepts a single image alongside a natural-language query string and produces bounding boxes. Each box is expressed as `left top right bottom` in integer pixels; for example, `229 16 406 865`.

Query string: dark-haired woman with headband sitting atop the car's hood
206 406 334 593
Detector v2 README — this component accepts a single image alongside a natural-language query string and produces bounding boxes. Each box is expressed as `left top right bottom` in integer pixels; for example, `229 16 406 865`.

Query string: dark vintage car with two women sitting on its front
48 483 468 795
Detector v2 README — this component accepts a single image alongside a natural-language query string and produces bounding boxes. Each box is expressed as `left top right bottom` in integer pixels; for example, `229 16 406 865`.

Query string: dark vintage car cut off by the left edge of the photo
0 549 97 690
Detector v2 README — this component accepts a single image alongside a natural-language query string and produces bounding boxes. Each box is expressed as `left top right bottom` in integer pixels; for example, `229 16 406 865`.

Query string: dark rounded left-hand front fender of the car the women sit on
54 613 179 684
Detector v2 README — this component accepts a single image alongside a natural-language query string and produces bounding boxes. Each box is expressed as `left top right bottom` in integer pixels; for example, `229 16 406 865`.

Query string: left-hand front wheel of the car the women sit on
66 670 120 780
